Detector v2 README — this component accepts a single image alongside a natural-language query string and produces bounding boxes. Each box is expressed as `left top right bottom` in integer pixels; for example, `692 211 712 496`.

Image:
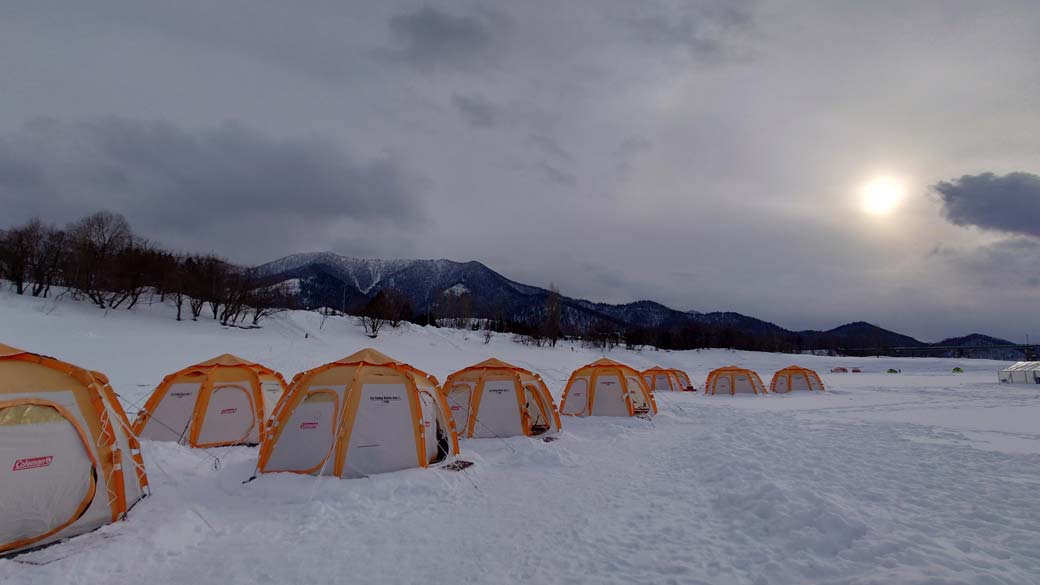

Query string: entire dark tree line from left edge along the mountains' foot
0 211 865 353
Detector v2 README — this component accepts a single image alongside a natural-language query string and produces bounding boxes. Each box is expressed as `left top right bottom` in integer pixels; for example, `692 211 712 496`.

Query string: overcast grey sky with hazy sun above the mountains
0 0 1040 341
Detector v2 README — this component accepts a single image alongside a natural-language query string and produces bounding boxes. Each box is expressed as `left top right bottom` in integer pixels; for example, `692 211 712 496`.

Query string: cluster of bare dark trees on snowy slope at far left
0 211 293 326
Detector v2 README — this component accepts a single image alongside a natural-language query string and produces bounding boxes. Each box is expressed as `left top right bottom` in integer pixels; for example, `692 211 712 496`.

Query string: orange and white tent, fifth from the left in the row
560 357 657 416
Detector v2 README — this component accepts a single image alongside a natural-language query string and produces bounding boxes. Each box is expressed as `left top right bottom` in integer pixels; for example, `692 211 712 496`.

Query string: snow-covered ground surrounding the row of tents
0 291 1040 585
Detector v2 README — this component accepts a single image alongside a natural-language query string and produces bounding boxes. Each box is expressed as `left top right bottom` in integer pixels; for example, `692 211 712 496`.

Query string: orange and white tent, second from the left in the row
133 354 285 448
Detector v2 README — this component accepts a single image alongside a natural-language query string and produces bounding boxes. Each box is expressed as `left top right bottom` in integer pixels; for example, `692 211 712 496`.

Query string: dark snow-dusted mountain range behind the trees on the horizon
252 252 1023 359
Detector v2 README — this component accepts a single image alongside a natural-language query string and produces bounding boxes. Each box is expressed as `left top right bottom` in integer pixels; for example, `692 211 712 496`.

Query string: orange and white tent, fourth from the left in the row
444 358 560 437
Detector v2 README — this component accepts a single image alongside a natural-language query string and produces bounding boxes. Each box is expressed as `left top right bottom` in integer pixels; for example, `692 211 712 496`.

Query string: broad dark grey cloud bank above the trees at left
0 118 422 255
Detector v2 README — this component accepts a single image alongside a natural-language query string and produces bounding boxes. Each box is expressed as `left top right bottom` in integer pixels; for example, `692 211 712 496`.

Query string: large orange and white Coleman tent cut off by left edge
0 344 148 555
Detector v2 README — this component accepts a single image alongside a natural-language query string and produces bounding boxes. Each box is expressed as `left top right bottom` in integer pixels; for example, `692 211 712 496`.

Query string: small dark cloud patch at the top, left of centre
388 4 510 71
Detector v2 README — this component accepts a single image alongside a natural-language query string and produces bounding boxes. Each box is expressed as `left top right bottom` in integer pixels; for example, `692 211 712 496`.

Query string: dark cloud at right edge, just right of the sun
932 173 1040 237
